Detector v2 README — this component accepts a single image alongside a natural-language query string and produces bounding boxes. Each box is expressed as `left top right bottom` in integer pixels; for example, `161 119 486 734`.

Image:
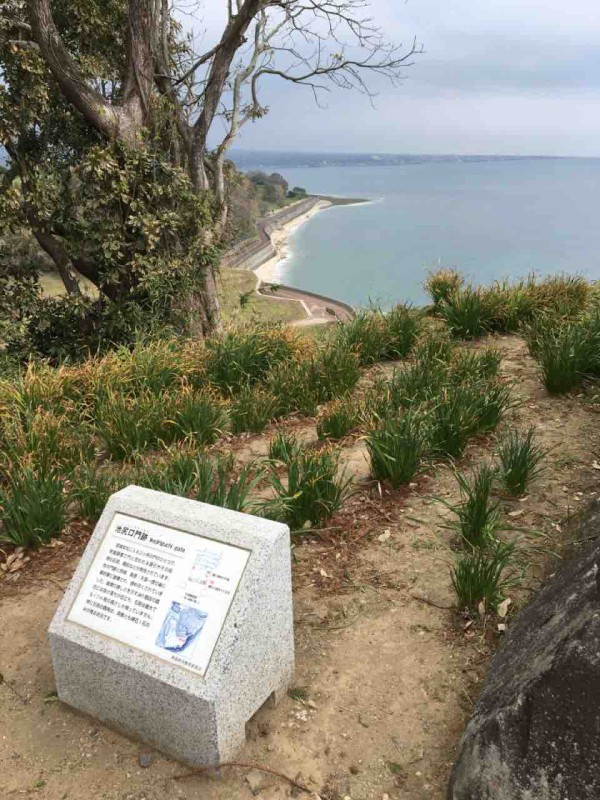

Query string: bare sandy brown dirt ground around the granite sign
0 337 600 800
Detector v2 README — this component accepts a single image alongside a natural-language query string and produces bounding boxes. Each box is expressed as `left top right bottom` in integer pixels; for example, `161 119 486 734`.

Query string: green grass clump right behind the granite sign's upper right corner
263 450 349 531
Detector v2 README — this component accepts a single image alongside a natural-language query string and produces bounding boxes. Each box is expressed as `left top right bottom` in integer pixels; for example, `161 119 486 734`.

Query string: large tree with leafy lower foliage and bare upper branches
0 0 418 354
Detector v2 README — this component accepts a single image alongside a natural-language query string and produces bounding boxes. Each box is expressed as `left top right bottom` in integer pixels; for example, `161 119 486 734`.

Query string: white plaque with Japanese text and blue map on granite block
68 514 250 675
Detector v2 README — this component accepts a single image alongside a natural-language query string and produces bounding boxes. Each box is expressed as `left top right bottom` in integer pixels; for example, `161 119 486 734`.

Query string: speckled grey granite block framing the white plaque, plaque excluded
49 486 294 766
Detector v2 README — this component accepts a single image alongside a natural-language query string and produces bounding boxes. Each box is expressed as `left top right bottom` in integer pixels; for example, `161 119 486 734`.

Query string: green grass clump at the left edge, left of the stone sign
0 467 67 547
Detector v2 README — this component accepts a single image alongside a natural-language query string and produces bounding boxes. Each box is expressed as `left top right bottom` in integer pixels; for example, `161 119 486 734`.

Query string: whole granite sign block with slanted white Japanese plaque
49 486 294 766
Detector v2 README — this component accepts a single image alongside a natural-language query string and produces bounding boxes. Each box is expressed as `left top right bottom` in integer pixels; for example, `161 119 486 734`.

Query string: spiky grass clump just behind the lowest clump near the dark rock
442 464 500 547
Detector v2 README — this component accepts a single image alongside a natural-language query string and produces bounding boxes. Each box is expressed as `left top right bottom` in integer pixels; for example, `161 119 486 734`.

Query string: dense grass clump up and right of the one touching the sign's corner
365 411 429 487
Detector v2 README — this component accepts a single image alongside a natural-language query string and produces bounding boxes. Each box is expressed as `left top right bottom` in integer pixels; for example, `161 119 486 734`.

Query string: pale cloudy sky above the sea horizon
190 0 600 156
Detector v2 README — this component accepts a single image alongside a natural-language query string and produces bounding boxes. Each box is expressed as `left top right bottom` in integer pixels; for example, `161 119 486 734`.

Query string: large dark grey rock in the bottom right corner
448 500 600 800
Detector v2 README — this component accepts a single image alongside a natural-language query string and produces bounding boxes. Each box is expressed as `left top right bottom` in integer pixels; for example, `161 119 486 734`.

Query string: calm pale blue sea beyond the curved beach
270 159 600 306
